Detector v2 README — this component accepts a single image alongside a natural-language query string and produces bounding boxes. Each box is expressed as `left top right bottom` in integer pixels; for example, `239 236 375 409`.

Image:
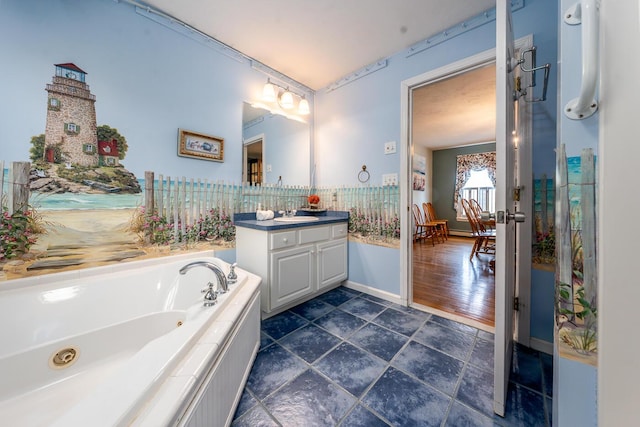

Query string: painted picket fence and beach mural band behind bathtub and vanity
0 162 400 280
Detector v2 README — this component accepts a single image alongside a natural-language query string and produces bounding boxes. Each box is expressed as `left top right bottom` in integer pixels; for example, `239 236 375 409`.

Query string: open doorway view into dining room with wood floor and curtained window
410 61 496 331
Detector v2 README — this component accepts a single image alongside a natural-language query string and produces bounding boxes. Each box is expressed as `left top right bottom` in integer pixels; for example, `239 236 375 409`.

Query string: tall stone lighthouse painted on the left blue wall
44 63 99 167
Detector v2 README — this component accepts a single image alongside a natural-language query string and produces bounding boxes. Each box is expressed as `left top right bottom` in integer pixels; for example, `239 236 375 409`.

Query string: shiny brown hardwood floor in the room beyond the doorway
413 236 495 327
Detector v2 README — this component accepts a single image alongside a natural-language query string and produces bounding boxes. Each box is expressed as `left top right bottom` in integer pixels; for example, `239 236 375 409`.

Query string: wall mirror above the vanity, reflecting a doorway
242 102 311 186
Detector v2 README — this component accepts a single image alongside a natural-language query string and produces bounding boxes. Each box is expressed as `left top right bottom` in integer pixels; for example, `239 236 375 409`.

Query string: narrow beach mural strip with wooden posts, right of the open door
555 144 598 366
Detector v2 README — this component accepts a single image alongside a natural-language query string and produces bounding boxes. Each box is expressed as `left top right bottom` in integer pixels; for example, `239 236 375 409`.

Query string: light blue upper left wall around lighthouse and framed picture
0 0 313 182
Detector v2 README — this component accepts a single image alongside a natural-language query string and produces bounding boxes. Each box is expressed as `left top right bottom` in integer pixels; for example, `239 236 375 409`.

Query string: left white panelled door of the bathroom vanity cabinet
270 245 315 310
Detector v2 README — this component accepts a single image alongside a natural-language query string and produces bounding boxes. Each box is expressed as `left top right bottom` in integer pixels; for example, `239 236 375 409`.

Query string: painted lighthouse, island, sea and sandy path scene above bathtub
0 63 232 280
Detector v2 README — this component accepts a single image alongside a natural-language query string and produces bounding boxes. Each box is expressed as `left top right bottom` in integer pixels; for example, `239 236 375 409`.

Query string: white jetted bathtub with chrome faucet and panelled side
0 252 260 427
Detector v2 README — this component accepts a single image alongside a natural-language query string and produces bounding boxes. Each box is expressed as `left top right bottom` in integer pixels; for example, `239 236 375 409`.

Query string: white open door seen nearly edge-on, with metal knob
493 0 522 416
